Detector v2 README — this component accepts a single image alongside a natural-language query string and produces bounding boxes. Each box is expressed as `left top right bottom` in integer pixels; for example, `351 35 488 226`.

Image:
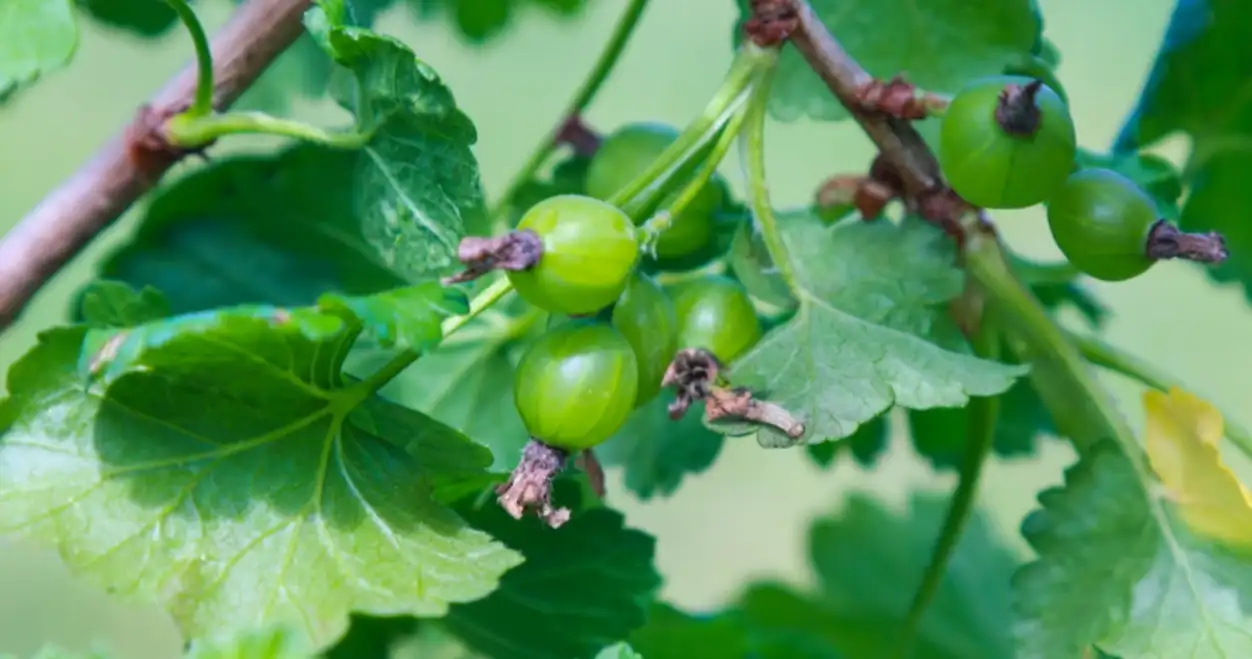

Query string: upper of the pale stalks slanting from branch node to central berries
608 41 777 218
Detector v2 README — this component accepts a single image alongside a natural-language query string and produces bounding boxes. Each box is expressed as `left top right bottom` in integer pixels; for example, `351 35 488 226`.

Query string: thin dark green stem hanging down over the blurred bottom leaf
899 307 1003 658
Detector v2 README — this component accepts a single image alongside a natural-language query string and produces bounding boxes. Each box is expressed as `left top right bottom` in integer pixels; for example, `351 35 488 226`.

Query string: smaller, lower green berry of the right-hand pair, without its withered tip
1048 168 1158 282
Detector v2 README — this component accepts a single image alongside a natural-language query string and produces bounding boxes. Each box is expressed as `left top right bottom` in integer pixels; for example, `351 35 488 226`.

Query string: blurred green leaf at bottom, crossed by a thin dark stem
731 492 1015 659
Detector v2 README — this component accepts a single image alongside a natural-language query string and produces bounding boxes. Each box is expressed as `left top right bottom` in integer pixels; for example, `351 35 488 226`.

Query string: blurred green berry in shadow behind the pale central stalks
586 123 722 258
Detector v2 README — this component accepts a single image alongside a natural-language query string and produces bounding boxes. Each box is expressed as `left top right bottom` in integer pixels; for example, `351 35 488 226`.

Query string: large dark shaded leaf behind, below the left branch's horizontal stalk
101 145 407 313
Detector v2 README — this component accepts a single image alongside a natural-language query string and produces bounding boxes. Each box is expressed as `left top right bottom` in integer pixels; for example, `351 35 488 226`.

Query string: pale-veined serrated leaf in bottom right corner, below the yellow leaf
1013 442 1252 659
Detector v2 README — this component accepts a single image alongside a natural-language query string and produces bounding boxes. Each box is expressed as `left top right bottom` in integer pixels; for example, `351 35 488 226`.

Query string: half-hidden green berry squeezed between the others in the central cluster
612 273 679 407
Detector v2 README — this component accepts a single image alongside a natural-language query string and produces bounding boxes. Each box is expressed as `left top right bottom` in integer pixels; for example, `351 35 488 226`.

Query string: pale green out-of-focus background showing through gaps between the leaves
0 0 1252 659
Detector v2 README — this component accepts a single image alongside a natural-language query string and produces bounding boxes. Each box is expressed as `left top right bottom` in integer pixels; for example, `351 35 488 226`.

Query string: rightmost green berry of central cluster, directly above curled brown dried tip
674 277 764 362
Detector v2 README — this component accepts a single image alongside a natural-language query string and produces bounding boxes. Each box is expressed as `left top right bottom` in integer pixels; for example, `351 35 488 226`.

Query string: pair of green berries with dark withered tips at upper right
939 75 1226 282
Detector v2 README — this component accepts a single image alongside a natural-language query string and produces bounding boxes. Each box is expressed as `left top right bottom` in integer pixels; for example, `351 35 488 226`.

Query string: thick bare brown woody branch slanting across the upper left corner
0 0 312 331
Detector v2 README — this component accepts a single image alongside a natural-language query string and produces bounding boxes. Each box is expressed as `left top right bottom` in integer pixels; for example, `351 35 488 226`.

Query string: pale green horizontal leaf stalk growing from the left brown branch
165 112 372 149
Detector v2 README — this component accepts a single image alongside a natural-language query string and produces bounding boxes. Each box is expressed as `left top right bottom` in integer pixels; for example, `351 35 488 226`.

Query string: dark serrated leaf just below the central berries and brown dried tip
596 391 724 501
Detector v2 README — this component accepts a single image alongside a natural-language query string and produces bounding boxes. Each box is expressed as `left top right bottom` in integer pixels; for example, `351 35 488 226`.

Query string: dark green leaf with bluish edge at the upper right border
1116 0 1252 299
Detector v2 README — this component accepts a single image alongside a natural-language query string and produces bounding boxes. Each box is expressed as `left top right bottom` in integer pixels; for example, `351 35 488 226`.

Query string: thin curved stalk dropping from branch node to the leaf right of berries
741 58 800 299
